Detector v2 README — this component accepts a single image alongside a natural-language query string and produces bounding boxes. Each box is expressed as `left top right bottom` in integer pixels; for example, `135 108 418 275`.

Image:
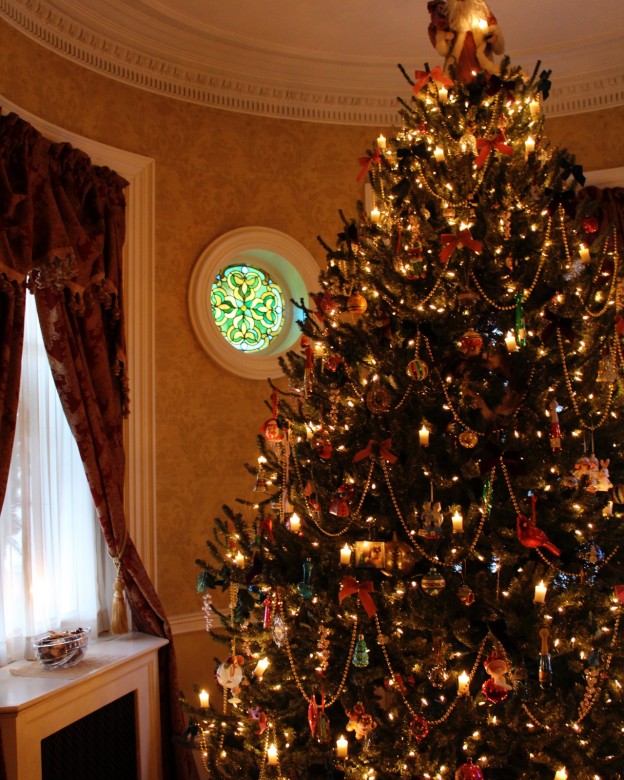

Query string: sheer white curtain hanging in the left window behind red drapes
0 295 114 664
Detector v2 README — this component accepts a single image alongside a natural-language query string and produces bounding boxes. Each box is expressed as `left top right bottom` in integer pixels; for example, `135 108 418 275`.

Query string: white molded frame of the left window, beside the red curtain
0 95 157 586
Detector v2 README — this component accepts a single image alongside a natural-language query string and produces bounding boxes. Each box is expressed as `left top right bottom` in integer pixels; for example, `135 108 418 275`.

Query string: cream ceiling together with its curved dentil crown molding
0 0 624 125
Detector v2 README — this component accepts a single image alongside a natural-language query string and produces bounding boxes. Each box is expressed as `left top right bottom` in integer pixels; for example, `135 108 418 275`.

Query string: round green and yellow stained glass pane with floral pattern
210 265 284 352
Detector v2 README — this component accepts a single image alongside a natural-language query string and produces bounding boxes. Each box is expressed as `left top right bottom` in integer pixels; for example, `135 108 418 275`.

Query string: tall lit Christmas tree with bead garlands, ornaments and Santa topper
185 0 624 780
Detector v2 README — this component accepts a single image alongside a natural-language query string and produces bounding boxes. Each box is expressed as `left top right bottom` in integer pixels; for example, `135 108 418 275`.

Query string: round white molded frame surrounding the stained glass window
188 226 320 380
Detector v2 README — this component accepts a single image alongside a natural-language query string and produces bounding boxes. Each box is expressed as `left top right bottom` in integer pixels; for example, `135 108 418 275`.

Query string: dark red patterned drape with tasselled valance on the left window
0 114 195 778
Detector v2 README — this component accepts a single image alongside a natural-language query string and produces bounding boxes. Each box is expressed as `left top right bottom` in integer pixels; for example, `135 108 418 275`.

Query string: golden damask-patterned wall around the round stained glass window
0 16 624 687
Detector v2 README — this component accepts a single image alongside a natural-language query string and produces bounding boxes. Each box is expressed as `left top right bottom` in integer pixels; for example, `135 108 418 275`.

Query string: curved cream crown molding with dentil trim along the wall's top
0 0 624 127
